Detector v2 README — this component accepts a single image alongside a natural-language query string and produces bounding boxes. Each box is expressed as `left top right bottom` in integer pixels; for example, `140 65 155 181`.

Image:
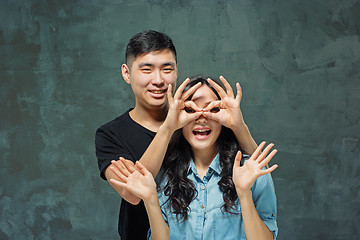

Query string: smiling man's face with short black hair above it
122 49 178 108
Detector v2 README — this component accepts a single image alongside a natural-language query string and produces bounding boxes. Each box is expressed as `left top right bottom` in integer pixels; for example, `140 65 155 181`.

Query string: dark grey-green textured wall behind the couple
0 0 360 239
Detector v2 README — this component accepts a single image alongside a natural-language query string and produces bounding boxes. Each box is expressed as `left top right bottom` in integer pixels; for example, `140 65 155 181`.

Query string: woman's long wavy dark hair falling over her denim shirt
163 76 242 221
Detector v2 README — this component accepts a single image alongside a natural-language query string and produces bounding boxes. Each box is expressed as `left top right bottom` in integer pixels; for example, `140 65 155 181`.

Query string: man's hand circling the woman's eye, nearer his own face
163 78 202 132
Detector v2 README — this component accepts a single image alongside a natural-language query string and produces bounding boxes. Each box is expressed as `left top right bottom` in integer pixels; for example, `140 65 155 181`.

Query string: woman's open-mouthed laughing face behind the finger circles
182 85 222 152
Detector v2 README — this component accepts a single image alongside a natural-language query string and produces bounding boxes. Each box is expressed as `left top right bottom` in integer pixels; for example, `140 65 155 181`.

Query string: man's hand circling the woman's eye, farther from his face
203 76 244 131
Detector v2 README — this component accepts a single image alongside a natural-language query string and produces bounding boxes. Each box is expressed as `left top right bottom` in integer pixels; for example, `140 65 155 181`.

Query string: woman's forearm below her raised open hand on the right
238 191 273 240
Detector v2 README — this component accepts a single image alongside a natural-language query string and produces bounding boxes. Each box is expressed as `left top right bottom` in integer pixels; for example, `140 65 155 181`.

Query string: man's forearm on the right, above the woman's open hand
232 120 257 155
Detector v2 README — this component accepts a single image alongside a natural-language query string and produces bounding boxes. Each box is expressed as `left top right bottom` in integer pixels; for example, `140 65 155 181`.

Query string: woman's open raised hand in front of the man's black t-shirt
110 159 157 202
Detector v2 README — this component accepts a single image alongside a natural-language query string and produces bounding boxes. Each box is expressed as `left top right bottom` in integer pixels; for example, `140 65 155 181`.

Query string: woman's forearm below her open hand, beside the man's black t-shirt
144 195 169 240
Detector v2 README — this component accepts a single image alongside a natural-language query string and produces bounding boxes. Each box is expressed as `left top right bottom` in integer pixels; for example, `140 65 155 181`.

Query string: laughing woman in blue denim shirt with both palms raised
111 77 277 240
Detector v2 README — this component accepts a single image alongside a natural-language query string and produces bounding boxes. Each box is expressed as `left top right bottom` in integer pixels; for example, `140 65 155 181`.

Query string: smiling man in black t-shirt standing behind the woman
95 30 256 240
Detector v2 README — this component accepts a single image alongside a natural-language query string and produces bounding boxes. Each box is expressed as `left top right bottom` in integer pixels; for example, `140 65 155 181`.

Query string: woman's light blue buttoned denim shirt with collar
148 154 278 240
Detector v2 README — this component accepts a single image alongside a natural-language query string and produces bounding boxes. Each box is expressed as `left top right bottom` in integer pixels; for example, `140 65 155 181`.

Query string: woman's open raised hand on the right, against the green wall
233 142 278 198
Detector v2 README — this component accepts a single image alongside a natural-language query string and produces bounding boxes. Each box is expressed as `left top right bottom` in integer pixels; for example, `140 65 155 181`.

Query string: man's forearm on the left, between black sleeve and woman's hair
139 124 174 178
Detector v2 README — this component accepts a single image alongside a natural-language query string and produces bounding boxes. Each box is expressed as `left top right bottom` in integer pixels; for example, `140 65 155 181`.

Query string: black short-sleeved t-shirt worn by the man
95 109 156 240
